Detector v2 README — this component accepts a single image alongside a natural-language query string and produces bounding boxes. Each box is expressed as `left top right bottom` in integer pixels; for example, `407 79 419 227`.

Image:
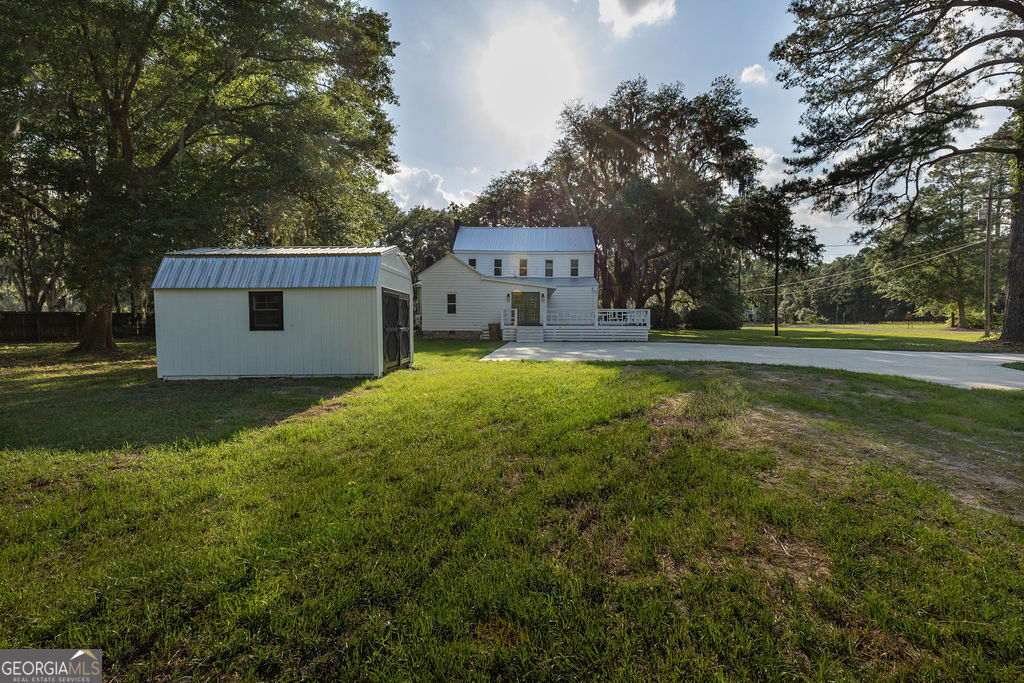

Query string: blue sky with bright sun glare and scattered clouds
367 0 913 258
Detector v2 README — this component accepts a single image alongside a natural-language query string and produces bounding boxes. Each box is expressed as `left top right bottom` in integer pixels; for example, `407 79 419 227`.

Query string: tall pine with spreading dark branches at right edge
772 0 1024 342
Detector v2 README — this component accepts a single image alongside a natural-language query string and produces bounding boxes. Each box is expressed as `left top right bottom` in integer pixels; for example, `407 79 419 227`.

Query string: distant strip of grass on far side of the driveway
650 324 1007 352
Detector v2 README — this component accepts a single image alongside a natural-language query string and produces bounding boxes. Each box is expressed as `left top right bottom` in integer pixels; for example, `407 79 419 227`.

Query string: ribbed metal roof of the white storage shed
153 247 398 290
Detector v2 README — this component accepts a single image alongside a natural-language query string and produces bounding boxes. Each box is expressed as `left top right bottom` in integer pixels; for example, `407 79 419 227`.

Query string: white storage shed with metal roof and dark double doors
153 247 413 380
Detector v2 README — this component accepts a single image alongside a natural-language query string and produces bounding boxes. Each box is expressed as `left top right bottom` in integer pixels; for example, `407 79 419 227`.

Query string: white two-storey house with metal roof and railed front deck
419 227 650 341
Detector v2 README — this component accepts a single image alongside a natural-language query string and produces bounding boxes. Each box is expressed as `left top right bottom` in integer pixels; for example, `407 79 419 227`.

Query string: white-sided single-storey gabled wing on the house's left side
420 258 547 332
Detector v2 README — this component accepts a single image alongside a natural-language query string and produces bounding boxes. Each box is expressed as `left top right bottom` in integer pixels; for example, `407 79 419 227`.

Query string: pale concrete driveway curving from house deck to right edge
483 342 1024 389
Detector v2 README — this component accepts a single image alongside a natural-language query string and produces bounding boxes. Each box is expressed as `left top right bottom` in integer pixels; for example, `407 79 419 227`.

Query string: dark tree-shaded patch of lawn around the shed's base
0 343 366 450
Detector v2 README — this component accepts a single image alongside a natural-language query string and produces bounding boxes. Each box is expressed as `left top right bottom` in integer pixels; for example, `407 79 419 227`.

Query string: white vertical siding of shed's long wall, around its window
154 281 382 379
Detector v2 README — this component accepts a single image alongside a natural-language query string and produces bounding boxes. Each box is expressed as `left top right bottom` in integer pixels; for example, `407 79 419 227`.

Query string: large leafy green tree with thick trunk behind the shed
0 0 394 351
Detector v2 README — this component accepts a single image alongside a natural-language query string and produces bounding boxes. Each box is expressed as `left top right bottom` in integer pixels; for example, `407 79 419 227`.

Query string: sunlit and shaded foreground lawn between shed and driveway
0 342 1024 680
